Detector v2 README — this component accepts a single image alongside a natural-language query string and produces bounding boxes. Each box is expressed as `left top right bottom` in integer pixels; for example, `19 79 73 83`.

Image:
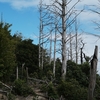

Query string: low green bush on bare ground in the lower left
13 79 35 96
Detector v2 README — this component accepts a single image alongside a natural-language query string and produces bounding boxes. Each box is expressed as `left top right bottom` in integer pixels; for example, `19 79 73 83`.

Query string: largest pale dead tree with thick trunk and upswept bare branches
52 0 83 80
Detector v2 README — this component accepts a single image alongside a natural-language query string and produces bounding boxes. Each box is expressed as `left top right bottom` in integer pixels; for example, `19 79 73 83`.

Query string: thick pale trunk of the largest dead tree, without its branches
62 0 67 80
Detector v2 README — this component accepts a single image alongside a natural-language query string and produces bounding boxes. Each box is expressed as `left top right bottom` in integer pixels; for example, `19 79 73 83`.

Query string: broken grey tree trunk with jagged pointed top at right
88 46 98 100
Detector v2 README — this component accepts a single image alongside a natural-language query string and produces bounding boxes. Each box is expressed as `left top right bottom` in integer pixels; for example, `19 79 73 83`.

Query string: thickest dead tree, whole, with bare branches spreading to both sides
39 0 83 80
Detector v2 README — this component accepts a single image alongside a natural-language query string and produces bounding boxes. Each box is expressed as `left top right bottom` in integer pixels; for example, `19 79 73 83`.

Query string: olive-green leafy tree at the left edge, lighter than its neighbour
0 22 16 81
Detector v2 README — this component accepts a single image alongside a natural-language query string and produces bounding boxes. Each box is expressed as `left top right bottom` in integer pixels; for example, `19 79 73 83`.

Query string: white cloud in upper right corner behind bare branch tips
69 0 99 21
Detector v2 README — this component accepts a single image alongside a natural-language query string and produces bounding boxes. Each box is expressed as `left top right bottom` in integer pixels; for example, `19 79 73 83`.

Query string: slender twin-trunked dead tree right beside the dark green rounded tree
39 0 49 69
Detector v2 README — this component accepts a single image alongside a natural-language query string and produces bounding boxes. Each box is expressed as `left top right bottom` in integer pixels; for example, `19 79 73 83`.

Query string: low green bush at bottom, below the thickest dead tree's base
57 79 87 100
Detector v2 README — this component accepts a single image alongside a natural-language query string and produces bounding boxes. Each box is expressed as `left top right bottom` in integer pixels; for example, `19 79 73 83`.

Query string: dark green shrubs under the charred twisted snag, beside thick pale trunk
67 61 89 87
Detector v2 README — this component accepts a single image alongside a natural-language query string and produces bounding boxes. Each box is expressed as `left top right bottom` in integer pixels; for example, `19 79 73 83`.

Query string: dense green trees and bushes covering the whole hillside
0 22 100 100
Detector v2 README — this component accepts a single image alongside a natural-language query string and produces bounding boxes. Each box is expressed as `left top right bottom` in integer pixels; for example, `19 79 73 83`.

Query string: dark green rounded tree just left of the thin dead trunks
16 39 38 77
